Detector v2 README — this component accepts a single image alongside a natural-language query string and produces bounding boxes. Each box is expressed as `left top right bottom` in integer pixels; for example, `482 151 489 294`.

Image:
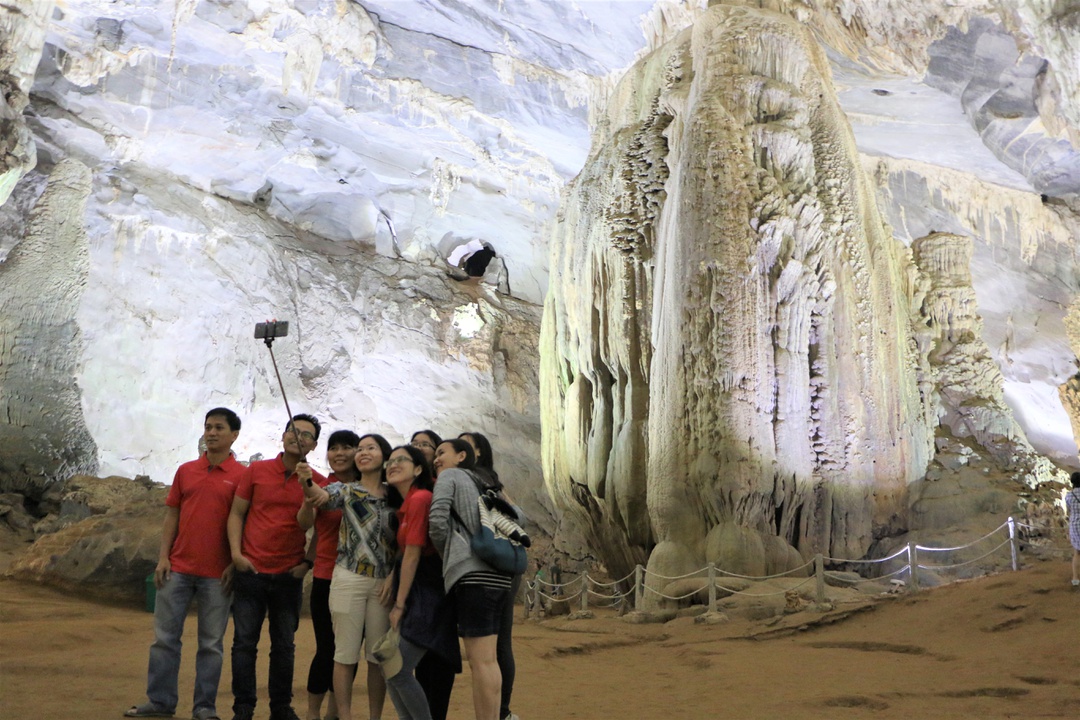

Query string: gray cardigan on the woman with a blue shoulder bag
428 467 494 593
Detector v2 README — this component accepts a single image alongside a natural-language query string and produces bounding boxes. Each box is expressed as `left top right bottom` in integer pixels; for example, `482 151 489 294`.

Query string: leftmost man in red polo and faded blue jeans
124 408 245 720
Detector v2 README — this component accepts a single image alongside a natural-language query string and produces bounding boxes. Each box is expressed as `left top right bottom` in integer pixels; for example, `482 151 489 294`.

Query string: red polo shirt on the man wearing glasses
237 454 326 574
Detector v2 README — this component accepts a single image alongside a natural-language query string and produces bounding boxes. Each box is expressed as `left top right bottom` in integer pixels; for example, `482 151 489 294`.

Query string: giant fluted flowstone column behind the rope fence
541 5 933 587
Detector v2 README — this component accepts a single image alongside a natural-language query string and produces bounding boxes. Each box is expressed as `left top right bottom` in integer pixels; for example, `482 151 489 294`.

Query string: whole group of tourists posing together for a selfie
124 408 521 720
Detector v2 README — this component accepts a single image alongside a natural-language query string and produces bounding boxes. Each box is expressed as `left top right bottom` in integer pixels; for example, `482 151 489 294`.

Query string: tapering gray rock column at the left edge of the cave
0 160 97 499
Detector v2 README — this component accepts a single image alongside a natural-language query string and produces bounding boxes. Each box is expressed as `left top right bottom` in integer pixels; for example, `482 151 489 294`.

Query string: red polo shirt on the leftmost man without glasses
165 453 246 578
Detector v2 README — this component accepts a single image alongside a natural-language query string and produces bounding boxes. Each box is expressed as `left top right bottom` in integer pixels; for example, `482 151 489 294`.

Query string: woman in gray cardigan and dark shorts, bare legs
428 438 511 720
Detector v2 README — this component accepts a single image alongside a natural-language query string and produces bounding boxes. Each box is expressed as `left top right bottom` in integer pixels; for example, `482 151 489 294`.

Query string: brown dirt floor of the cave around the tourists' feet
0 560 1080 720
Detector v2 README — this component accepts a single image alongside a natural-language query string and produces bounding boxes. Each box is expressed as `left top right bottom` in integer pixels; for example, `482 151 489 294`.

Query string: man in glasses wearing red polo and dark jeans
228 415 326 720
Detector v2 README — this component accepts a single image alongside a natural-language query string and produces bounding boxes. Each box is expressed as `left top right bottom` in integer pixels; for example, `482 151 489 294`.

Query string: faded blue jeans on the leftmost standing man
146 572 229 715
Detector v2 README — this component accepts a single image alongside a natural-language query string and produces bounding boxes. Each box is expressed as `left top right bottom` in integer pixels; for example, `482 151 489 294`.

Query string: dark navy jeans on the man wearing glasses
232 572 303 716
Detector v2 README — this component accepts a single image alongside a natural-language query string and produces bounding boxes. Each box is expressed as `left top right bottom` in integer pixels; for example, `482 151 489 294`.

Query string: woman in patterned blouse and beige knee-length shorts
297 433 394 720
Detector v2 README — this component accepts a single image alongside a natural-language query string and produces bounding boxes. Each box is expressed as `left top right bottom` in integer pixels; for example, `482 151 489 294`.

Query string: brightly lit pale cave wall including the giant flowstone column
0 0 1080 570
